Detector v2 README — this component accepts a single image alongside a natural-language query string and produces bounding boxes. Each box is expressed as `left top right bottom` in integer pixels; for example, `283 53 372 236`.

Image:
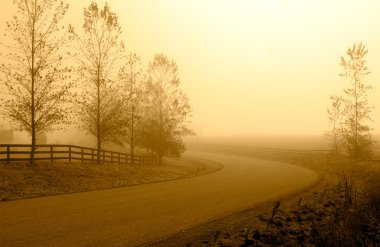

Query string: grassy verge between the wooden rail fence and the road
0 159 217 201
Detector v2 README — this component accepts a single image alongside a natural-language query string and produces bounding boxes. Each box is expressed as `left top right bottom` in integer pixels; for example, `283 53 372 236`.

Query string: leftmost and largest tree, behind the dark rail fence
0 0 72 163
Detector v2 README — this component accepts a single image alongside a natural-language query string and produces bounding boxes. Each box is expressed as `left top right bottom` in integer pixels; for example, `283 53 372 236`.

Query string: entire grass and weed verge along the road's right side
157 146 380 246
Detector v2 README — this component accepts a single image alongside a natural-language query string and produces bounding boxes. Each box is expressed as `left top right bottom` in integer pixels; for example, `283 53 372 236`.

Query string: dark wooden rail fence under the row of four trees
0 144 154 165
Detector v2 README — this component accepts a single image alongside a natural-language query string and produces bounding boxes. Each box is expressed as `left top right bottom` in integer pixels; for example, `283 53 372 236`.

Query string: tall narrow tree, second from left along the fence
70 2 124 163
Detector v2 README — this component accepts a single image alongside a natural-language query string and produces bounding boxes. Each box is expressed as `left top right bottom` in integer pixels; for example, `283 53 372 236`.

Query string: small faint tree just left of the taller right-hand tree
325 96 344 154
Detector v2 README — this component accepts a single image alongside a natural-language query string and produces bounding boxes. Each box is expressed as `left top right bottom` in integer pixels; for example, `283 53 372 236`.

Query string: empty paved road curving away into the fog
0 152 318 246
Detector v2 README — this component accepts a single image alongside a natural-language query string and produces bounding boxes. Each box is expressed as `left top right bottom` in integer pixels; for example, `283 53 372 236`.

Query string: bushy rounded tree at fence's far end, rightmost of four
144 54 193 164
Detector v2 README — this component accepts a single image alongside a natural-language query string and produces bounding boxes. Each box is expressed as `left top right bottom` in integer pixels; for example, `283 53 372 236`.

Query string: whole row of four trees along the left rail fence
0 0 193 166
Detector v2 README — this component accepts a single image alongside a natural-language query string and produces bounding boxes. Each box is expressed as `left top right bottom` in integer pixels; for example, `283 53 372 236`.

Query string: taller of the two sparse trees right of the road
340 43 373 161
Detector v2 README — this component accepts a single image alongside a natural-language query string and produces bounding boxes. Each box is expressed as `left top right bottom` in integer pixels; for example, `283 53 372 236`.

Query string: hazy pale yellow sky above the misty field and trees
0 0 380 135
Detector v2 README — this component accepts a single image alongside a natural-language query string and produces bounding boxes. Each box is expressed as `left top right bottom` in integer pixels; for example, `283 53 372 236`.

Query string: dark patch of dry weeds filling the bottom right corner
218 162 380 246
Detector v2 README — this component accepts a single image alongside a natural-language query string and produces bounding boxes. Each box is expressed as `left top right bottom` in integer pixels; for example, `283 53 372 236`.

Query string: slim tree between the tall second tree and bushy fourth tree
119 53 146 164
